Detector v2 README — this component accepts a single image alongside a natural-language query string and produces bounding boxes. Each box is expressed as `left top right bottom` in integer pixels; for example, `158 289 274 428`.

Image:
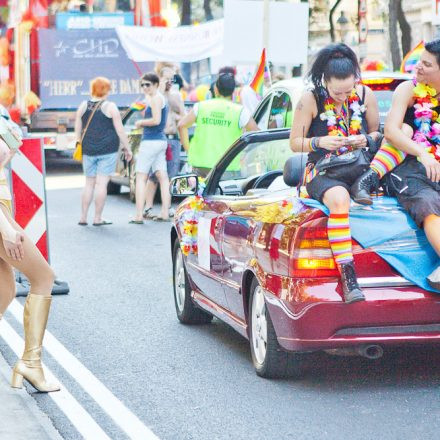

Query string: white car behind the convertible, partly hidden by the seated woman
254 72 413 130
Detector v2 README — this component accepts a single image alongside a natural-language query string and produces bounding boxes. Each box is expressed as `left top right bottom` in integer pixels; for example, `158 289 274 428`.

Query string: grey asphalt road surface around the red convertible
0 162 440 440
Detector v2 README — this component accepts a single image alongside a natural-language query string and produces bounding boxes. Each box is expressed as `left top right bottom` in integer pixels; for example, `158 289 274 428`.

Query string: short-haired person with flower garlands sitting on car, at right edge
358 39 440 290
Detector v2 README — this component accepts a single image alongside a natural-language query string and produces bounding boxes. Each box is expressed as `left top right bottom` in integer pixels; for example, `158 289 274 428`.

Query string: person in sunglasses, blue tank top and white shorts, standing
130 72 171 224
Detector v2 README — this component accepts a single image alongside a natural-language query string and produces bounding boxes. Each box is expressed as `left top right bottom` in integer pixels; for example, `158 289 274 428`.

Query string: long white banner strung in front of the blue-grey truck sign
116 20 224 62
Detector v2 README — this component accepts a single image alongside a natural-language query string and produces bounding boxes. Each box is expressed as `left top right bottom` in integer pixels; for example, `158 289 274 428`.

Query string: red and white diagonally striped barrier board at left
11 139 49 261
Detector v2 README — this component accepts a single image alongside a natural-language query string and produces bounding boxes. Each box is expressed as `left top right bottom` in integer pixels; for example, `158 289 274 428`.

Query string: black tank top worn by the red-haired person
81 101 119 156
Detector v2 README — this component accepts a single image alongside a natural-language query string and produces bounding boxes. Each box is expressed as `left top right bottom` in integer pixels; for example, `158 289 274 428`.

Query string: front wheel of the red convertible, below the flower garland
173 240 212 324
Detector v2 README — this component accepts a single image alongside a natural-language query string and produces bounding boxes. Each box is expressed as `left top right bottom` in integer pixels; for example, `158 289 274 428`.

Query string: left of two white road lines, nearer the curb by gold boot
0 318 111 440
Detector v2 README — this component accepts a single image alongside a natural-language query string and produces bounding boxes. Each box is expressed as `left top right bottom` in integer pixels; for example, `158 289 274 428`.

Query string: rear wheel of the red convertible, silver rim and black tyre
249 278 303 379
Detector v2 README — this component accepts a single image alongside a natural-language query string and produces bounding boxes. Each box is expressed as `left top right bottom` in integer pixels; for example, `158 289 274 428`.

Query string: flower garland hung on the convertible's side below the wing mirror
180 177 206 256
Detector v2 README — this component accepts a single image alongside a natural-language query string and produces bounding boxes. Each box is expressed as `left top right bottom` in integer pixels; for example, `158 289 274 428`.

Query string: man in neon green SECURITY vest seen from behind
178 73 258 177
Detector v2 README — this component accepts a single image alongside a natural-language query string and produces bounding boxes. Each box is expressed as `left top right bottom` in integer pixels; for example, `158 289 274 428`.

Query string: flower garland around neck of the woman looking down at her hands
319 89 366 155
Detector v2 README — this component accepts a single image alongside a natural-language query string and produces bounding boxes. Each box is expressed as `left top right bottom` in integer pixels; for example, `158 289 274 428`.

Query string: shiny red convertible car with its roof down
171 129 440 377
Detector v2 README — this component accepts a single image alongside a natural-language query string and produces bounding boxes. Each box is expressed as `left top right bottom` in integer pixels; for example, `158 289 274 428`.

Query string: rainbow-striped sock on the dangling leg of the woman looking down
327 213 353 264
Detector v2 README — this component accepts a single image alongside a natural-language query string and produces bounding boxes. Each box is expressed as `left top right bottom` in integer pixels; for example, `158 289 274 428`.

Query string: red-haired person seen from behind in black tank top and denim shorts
75 77 132 226
